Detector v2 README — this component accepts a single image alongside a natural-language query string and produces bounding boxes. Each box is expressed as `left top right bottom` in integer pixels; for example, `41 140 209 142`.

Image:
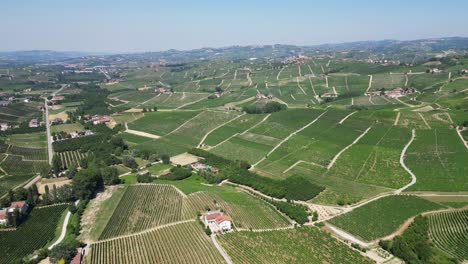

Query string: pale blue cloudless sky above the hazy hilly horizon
0 0 468 53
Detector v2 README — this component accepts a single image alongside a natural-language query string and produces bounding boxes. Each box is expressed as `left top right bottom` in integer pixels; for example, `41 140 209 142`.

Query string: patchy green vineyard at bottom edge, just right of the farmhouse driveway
218 227 372 264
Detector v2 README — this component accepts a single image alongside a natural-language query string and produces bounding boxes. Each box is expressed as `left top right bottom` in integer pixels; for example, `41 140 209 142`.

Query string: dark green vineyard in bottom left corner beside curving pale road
0 204 68 264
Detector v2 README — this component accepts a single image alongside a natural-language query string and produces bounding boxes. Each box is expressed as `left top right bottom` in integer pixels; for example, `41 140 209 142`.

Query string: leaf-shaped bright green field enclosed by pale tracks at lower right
330 195 442 241
